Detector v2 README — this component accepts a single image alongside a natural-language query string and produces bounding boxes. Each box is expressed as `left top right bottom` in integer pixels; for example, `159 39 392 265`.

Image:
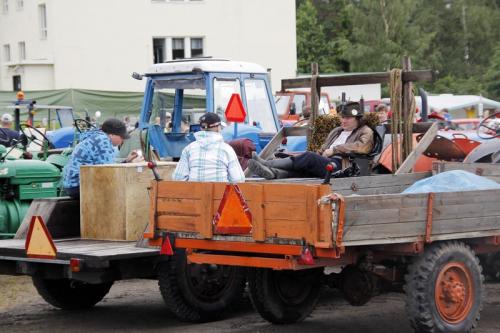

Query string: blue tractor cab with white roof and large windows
139 58 279 159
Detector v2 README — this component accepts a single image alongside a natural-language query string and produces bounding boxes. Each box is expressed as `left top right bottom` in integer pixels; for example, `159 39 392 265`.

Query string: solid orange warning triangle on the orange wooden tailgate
213 185 252 234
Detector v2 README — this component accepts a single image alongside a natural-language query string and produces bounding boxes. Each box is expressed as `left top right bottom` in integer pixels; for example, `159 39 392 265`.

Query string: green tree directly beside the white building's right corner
297 0 336 73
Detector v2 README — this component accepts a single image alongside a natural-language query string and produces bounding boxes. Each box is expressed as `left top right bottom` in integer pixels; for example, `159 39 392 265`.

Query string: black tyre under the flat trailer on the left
33 276 113 310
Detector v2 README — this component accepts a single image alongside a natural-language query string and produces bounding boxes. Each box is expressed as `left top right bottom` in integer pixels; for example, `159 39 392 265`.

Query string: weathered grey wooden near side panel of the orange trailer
343 190 500 246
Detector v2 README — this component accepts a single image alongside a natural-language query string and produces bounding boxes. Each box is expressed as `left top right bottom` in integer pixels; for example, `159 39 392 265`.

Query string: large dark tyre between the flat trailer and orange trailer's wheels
158 250 246 322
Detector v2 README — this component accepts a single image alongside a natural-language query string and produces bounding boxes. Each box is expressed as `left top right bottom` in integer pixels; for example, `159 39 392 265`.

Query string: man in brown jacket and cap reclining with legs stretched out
248 102 374 179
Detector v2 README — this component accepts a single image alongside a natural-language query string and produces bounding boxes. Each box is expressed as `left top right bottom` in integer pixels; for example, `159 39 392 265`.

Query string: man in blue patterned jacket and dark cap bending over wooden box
63 118 130 199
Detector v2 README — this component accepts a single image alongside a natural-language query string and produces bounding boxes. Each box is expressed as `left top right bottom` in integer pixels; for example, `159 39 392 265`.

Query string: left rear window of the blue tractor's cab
150 75 206 133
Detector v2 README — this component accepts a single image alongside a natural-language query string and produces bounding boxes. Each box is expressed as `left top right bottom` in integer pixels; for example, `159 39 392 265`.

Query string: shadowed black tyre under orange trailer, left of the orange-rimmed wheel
248 268 323 324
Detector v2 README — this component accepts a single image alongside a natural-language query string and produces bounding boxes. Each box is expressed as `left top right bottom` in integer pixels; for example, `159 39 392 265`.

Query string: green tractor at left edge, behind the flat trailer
0 145 70 239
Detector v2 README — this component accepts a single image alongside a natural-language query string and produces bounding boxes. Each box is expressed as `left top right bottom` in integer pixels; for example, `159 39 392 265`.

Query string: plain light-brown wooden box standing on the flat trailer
80 162 176 240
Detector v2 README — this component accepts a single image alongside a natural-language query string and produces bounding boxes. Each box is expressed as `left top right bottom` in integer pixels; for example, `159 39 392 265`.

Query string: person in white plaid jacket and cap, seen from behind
172 112 245 183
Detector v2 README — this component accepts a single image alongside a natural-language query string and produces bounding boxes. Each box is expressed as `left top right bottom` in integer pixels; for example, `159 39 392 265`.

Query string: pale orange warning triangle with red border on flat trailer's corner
24 216 57 259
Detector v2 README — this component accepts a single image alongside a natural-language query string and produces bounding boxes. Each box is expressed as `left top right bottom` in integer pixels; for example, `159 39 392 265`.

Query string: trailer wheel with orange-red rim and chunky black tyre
404 242 483 333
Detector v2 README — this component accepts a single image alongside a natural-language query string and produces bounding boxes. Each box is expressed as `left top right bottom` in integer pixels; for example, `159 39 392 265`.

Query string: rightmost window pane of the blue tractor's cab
245 79 278 133
